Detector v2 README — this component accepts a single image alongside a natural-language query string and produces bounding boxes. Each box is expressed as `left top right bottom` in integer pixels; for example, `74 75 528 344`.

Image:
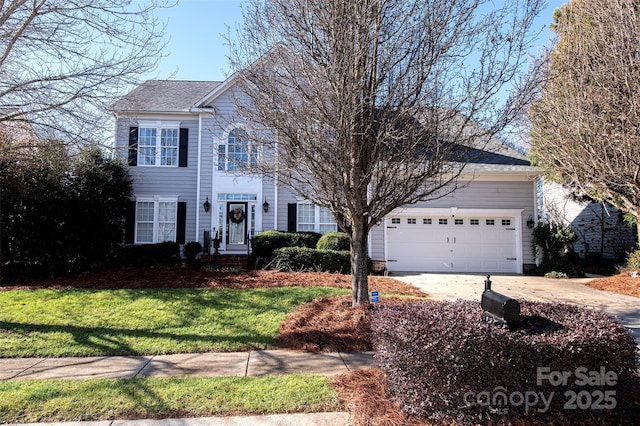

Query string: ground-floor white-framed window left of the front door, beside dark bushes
135 198 178 244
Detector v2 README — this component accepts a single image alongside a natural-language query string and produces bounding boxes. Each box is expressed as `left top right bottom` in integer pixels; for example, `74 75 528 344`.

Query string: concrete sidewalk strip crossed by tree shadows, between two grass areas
0 350 374 380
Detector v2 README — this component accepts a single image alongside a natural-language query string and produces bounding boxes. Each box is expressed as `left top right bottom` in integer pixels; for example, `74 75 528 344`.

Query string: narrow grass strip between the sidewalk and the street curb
0 374 341 423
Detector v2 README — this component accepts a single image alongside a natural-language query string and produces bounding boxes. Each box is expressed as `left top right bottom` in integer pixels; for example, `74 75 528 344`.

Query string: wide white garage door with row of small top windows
387 216 517 273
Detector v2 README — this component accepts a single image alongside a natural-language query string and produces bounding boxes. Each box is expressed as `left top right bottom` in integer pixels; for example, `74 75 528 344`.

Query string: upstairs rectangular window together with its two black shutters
129 121 189 167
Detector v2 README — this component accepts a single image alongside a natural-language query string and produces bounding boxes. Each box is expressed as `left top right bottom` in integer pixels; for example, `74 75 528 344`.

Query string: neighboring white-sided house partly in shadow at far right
541 182 637 261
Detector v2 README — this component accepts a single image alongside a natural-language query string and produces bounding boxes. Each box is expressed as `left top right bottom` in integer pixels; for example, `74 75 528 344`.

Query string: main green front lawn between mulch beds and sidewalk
0 287 349 358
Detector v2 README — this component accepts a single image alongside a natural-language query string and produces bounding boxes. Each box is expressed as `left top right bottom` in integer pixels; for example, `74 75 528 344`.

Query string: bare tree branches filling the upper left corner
0 0 172 142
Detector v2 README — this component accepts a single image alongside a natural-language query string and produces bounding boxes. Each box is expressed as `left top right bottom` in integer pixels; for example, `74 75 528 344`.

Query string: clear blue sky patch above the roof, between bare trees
149 0 566 81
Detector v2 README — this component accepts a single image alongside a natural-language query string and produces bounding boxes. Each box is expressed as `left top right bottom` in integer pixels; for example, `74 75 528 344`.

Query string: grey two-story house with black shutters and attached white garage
112 77 538 273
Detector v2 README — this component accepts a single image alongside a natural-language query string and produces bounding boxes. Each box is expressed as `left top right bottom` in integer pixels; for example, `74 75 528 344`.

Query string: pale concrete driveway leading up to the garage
390 272 640 345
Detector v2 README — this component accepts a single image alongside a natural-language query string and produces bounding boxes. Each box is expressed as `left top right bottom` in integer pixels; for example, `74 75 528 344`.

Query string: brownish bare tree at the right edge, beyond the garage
531 0 640 245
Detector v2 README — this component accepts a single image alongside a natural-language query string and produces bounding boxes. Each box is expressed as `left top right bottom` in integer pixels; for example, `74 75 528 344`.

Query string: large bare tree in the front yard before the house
231 0 541 305
